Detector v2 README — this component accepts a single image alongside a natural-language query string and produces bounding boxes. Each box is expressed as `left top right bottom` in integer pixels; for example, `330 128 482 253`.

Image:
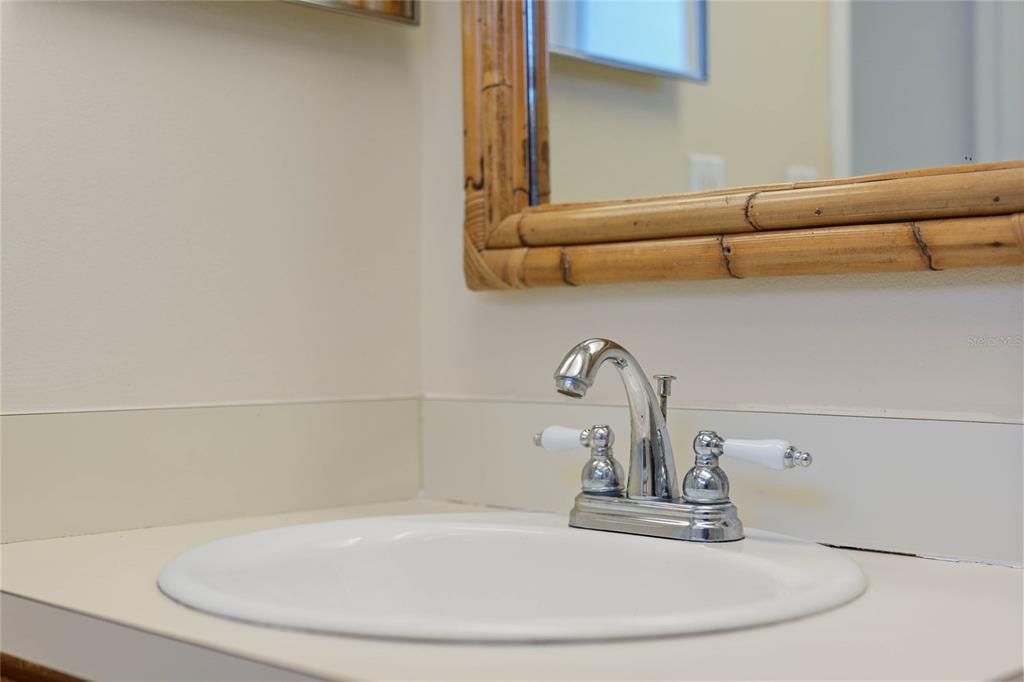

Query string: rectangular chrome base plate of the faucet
569 493 743 543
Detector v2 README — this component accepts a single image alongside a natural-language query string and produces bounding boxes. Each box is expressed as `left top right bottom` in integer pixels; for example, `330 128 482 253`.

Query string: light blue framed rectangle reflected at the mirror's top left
547 0 707 80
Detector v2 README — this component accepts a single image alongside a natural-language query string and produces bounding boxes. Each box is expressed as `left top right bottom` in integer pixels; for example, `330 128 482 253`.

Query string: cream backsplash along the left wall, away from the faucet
0 398 420 542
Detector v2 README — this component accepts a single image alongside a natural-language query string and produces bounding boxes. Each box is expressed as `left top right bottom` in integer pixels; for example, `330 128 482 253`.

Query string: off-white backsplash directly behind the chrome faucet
422 399 1024 565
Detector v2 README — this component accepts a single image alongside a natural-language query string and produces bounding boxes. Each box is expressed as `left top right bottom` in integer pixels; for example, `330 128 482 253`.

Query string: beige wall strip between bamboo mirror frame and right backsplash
421 3 1024 422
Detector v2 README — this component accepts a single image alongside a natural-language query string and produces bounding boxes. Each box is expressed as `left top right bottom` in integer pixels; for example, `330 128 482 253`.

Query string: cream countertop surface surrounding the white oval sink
0 500 1024 680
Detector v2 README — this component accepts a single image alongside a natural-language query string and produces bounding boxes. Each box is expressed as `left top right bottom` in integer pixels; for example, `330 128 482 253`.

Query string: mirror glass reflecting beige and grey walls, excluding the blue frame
548 0 1024 203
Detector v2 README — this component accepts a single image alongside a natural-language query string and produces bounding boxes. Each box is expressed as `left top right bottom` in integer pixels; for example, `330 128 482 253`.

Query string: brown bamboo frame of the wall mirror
462 0 1024 290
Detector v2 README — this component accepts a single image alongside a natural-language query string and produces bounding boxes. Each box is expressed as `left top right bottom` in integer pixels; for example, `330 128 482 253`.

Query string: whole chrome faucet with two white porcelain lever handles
534 339 811 542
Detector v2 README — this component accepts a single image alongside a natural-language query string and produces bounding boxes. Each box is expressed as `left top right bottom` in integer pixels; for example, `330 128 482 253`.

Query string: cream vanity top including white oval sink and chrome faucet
2 338 1022 682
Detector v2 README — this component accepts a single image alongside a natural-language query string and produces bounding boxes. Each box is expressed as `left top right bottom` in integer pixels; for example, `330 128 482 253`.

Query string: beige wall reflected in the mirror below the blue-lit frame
549 2 831 202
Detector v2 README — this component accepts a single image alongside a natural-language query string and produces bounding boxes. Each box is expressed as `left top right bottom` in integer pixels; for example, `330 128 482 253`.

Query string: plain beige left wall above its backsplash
2 2 422 414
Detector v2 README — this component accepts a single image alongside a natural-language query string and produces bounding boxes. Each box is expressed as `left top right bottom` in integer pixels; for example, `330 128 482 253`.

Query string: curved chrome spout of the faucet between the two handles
555 339 679 500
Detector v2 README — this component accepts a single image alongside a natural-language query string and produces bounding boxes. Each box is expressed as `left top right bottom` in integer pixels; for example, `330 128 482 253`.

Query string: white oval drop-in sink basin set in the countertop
160 512 866 642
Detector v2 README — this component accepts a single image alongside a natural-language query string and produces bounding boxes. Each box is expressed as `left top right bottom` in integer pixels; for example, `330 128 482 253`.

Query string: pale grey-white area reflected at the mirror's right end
850 0 1024 174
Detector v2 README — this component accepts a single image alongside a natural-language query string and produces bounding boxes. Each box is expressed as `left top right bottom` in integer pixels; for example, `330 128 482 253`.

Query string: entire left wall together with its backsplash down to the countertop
0 2 423 541
